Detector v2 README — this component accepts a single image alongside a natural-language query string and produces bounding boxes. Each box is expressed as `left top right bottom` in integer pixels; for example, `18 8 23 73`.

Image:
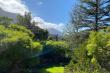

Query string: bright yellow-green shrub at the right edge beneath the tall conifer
87 32 110 71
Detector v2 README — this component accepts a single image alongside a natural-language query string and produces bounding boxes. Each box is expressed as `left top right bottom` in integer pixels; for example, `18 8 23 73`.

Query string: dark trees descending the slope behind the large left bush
17 13 48 40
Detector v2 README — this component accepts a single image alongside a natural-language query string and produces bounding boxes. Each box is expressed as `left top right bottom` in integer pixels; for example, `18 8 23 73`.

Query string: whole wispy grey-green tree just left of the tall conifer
65 5 88 49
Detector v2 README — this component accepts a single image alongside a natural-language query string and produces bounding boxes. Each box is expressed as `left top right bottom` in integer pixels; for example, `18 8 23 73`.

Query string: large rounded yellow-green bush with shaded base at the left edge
0 25 42 73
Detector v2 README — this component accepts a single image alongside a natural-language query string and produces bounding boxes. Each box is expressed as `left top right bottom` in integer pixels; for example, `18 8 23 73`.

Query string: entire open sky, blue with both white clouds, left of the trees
0 0 77 31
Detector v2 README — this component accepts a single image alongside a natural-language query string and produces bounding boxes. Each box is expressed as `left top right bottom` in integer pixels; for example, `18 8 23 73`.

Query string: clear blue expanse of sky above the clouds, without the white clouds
23 0 77 24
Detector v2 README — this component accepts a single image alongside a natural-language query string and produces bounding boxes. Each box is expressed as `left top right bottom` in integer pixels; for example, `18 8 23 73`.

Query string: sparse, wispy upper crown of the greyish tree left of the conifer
68 4 86 33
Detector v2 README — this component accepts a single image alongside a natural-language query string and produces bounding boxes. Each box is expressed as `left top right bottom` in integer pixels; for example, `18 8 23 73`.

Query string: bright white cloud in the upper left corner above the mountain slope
0 0 29 15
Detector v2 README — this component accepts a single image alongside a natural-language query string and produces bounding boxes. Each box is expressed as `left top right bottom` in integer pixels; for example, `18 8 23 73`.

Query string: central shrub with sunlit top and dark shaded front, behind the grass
42 41 69 64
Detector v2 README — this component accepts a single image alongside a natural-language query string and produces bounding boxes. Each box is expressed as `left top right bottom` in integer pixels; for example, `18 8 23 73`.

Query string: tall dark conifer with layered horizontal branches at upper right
81 0 110 31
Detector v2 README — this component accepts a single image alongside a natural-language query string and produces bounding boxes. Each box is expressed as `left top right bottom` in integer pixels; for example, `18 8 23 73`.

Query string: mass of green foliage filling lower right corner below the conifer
67 31 110 73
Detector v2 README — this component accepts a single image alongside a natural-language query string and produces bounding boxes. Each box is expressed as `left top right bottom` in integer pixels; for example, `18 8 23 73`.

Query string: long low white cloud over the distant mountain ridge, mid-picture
33 17 64 32
